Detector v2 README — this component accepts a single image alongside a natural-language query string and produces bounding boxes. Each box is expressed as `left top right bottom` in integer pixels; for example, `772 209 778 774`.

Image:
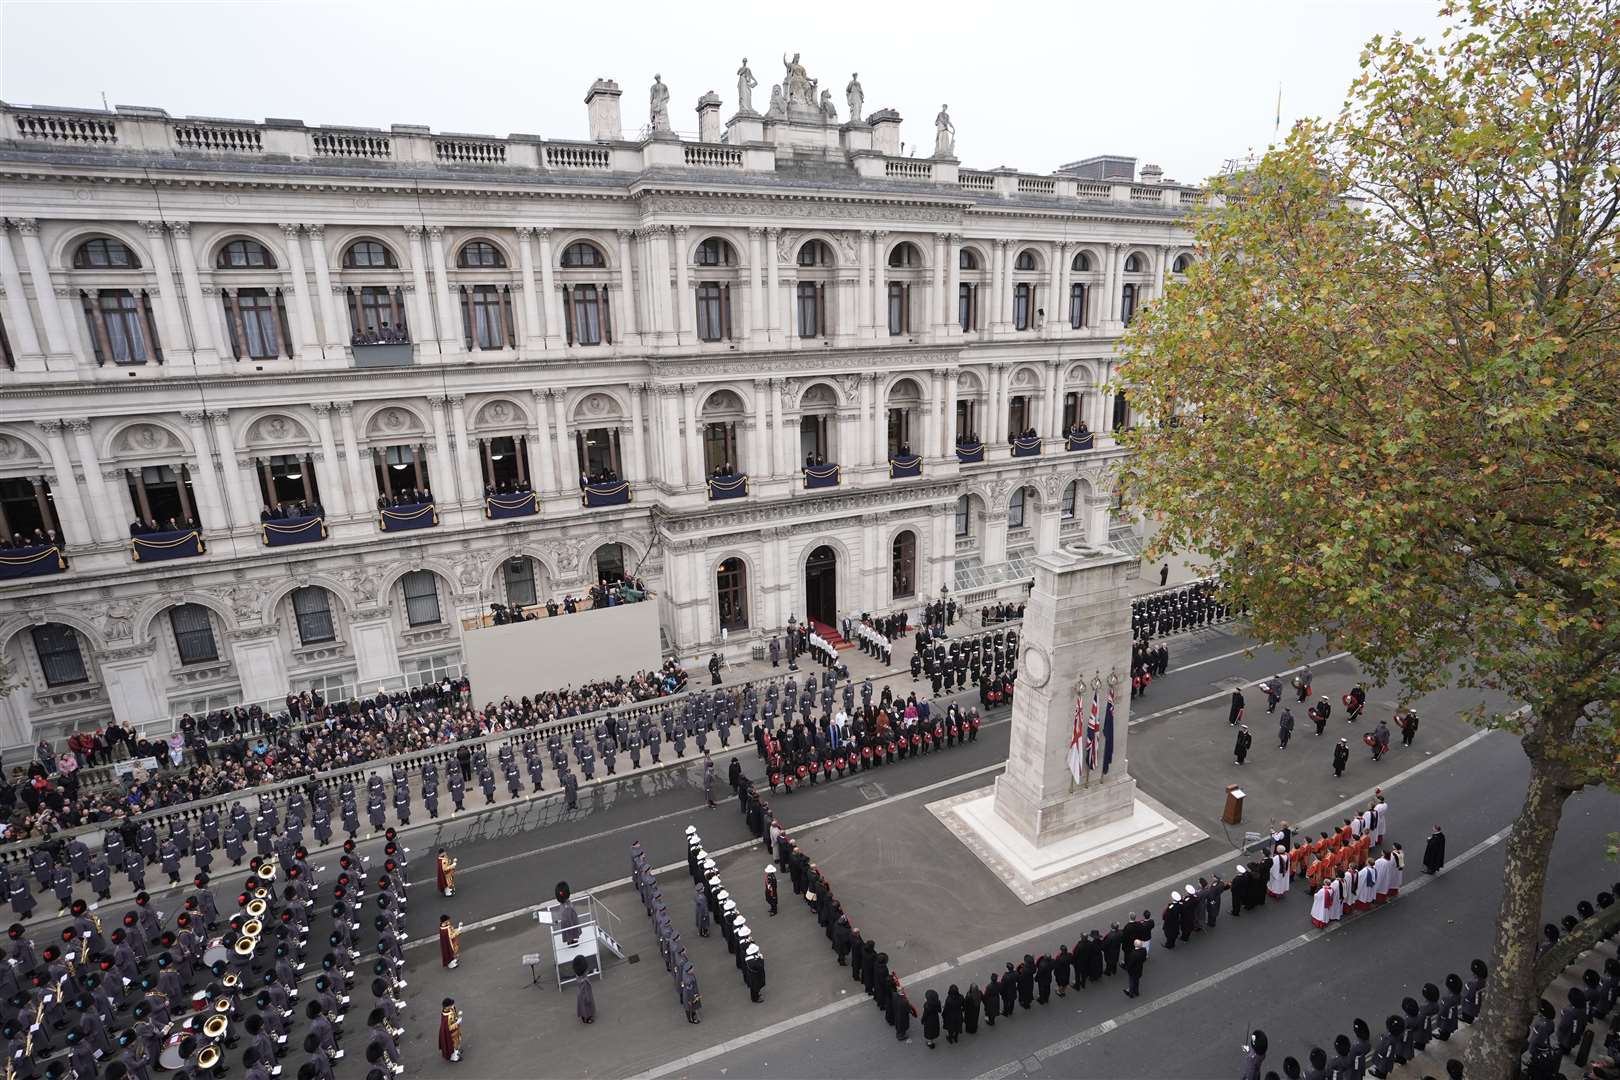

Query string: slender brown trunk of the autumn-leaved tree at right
1463 755 1570 1080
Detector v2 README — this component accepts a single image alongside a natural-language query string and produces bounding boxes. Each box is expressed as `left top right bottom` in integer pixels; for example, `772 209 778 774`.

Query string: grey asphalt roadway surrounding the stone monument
358 627 1620 1078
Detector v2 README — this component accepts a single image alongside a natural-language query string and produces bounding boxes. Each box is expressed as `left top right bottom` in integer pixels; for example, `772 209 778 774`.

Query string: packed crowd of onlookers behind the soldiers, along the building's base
0 661 687 840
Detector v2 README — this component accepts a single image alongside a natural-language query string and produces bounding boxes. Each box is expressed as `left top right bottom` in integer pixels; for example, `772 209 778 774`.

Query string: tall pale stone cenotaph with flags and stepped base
928 544 1205 904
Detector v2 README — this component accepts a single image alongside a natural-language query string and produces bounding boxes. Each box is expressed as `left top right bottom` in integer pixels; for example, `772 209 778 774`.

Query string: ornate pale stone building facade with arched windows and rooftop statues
0 61 1202 746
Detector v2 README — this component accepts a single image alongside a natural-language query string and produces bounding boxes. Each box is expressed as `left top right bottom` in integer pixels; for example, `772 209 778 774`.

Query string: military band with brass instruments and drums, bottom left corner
0 819 408 1080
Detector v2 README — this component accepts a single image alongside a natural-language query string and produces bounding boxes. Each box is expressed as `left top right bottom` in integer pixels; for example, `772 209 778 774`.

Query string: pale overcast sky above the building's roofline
0 0 1439 181
